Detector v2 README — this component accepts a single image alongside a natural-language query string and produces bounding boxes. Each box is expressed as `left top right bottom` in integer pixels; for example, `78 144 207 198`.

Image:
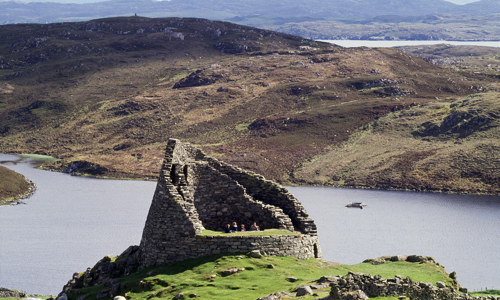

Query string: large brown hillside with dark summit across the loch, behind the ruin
0 17 498 193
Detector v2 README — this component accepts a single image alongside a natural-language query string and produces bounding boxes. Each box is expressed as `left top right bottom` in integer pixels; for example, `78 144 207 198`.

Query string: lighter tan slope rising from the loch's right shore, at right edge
296 93 500 194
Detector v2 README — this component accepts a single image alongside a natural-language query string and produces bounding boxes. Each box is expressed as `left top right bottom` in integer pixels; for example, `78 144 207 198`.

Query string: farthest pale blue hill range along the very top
0 0 500 23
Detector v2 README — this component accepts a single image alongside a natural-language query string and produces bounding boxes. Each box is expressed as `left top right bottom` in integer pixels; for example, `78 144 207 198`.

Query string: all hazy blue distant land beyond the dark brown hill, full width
0 0 500 40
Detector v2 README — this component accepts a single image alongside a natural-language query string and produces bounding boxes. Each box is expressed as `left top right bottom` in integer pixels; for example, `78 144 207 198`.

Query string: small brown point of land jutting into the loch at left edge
0 166 34 205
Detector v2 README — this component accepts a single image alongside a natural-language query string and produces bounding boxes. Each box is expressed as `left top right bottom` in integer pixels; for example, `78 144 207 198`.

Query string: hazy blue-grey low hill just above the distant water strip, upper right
268 14 500 41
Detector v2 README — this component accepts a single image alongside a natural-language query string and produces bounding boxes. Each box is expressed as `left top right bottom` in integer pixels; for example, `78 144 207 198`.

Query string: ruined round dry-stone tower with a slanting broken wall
139 139 321 266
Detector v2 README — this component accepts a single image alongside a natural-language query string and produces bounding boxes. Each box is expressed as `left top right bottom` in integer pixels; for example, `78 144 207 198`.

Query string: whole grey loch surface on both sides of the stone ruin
0 154 500 295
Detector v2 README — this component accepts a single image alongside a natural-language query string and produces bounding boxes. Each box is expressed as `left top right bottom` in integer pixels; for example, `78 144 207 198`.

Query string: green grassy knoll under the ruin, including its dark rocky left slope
64 255 460 299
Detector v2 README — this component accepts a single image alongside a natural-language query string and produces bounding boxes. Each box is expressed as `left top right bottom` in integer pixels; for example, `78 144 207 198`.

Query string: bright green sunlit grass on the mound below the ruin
65 255 452 299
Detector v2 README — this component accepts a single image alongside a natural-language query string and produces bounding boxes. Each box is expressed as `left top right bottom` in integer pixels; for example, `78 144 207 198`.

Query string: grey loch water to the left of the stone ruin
0 155 155 295
